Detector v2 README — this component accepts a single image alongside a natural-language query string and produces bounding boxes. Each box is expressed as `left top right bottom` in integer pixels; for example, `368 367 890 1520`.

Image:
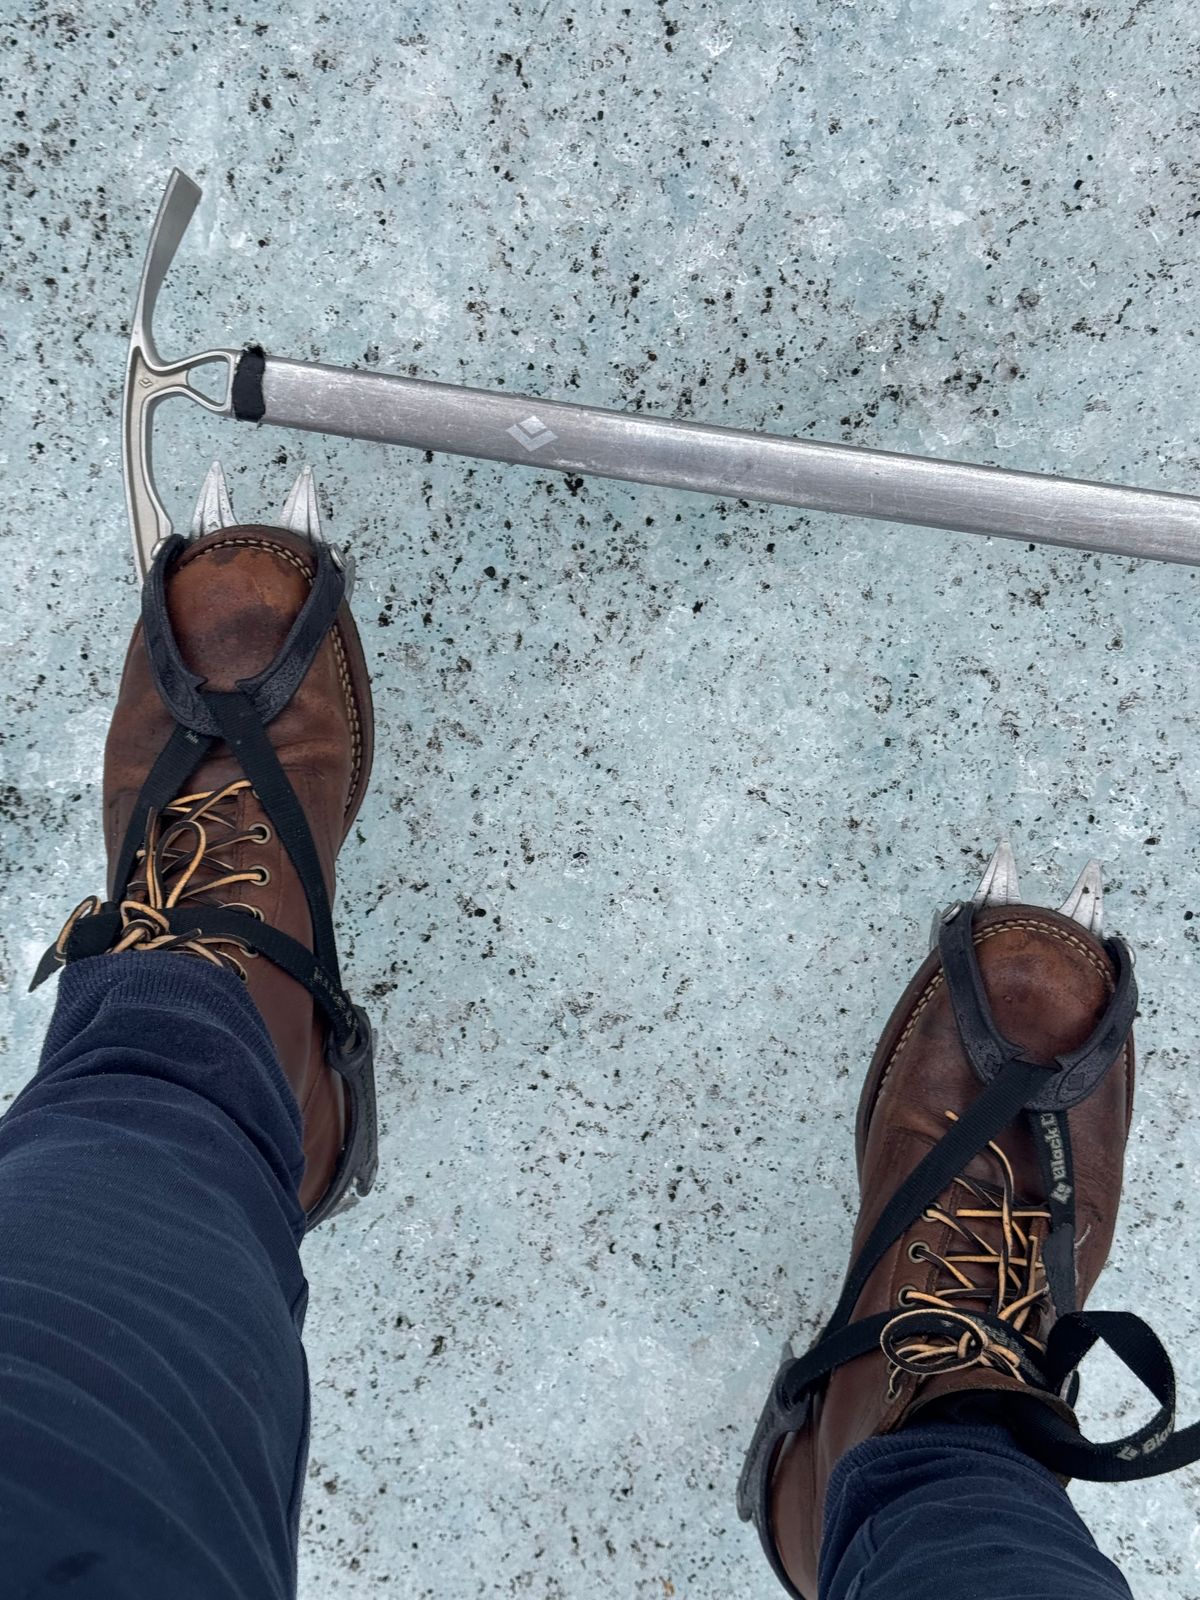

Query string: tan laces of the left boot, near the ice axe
54 778 270 979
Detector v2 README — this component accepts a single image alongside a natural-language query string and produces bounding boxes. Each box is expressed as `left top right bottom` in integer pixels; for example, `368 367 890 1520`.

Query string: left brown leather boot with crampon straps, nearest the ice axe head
40 502 376 1226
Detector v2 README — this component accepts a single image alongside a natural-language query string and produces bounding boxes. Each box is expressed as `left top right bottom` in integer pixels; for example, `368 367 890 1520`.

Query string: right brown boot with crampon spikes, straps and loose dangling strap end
738 845 1200 1600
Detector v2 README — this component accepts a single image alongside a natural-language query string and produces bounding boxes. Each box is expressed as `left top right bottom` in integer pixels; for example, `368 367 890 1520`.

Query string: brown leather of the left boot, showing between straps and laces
104 526 373 1210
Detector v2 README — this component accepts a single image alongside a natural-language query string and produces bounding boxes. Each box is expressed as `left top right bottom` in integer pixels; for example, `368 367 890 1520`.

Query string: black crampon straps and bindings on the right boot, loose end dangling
738 907 1200 1597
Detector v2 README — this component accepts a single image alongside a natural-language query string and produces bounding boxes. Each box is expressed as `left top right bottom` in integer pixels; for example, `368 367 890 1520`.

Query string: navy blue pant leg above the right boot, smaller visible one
819 1422 1131 1600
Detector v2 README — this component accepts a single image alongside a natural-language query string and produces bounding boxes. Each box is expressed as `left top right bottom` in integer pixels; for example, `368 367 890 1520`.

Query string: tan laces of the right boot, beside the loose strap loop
880 1110 1050 1400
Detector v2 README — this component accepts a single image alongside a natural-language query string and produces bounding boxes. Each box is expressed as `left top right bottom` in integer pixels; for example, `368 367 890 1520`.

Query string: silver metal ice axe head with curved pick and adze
123 166 242 578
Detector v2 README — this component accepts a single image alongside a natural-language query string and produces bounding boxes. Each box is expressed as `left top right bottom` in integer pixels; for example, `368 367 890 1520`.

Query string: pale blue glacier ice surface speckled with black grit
0 0 1200 1600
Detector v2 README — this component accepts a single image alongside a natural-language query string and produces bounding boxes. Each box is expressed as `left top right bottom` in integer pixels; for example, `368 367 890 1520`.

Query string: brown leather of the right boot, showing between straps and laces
771 906 1134 1595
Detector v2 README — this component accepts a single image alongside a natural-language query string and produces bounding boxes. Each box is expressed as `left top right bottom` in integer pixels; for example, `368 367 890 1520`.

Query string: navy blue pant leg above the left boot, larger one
0 952 309 1600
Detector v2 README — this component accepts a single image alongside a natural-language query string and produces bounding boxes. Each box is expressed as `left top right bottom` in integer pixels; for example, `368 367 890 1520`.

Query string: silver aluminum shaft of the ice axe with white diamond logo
262 357 1200 565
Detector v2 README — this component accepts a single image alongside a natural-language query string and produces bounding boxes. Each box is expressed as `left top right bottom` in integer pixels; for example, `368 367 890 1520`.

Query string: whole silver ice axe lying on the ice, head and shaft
125 168 1200 576
